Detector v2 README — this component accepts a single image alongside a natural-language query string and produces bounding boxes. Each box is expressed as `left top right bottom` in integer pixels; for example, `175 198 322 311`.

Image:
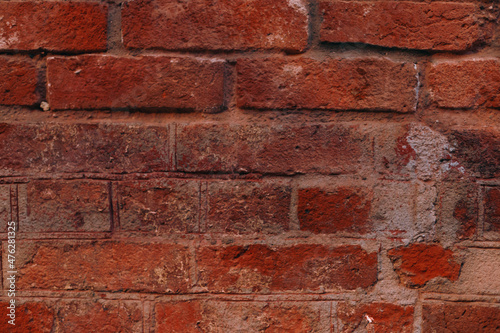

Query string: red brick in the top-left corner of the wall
0 1 108 52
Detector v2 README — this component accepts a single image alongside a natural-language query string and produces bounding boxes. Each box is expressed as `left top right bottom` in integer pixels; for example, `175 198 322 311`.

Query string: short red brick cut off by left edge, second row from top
0 56 39 106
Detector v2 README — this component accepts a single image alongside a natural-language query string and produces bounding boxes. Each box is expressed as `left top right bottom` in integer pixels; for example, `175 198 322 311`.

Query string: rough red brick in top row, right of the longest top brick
320 1 483 51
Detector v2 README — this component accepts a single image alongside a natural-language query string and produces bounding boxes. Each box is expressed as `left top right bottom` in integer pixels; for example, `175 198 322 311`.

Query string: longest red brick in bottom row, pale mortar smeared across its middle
155 300 330 333
